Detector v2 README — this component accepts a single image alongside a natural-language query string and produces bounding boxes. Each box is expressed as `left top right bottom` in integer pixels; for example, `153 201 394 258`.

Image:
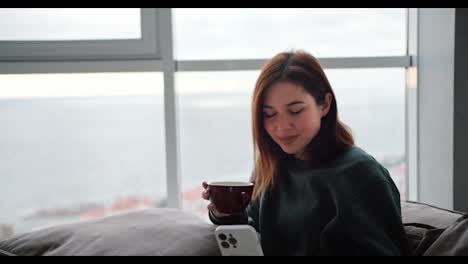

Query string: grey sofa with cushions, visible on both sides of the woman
0 201 468 256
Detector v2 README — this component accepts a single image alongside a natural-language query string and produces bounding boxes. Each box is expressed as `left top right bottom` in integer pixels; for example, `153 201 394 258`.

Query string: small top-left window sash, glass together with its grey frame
0 8 161 61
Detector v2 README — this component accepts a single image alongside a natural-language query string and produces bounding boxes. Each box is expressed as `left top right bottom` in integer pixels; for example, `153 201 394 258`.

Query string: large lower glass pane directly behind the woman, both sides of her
177 69 406 221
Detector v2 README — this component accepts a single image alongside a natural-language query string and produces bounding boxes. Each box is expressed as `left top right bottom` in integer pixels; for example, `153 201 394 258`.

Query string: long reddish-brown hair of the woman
251 51 354 199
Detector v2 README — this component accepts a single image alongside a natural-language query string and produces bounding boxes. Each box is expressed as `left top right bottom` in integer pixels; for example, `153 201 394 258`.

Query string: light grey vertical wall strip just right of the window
417 8 455 209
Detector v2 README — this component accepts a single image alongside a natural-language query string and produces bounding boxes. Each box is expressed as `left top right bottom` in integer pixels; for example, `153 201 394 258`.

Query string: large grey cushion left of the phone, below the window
0 208 220 256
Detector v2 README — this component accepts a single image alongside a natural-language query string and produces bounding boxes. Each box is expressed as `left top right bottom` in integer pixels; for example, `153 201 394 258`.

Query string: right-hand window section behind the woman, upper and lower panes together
173 8 409 219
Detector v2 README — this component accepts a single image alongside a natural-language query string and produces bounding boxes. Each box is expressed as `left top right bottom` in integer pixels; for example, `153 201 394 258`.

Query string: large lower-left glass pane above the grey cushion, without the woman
0 73 167 237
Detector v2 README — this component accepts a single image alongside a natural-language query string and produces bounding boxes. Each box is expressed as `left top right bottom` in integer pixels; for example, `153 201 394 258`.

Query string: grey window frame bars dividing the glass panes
0 8 418 208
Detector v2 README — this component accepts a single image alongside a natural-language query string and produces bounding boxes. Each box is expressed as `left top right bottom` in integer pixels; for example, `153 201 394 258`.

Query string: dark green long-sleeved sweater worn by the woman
210 147 409 255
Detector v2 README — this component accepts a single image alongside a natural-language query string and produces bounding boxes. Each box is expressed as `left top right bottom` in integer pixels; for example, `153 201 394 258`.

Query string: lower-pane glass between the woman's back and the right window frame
325 68 407 198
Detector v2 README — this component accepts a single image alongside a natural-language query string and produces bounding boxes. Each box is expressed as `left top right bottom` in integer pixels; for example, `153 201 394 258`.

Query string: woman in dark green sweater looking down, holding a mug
202 51 409 255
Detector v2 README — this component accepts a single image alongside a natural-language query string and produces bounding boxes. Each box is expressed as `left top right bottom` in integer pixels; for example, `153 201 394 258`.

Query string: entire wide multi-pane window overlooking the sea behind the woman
0 8 417 232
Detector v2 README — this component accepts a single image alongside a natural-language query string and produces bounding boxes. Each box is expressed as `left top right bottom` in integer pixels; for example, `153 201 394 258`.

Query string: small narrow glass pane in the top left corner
0 8 141 41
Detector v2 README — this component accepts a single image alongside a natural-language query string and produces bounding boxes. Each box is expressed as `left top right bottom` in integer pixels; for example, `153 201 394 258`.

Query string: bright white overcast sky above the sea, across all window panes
0 8 406 97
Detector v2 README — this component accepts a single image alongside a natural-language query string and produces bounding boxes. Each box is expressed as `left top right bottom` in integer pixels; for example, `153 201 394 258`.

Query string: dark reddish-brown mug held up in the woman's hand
208 181 254 214
